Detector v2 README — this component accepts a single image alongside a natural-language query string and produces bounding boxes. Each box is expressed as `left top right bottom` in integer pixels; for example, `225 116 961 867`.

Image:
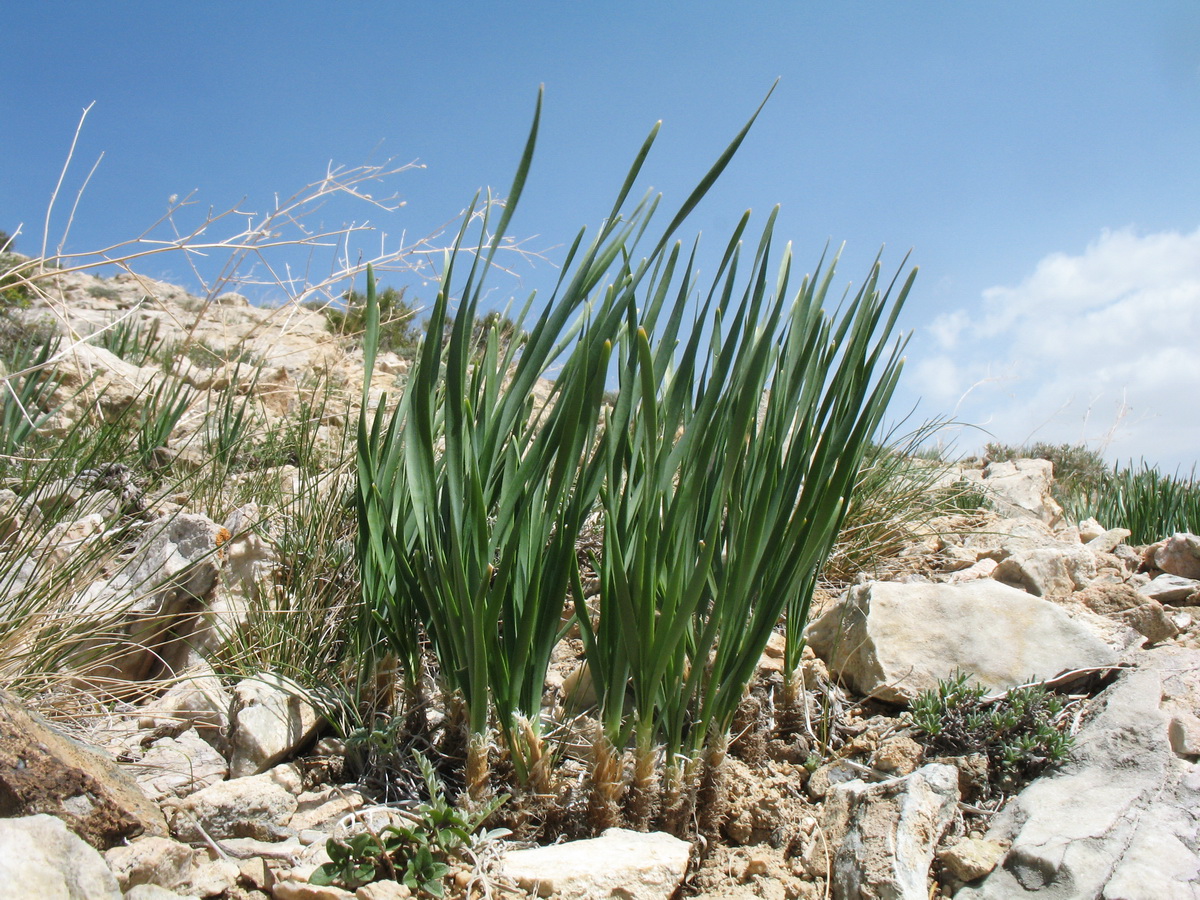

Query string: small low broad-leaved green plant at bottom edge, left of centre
308 752 508 898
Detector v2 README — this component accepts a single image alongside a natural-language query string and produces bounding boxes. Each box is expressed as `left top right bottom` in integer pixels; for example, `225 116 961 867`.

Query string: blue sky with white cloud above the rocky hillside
0 7 1200 468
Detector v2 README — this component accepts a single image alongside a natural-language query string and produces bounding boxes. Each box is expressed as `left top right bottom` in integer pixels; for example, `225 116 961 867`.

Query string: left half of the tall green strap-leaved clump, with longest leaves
358 88 768 793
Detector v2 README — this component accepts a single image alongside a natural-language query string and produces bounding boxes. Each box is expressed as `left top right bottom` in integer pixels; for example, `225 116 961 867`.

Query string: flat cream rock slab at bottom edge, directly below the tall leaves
504 828 691 900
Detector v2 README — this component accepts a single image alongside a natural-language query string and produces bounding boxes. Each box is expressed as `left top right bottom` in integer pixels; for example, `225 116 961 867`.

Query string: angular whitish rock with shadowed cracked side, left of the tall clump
229 672 322 778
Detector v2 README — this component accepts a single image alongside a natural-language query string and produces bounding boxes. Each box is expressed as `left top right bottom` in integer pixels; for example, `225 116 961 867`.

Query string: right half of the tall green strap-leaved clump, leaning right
580 215 913 830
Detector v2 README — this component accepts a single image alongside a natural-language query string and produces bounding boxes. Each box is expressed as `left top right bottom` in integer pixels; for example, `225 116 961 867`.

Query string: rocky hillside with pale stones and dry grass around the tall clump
0 267 1200 900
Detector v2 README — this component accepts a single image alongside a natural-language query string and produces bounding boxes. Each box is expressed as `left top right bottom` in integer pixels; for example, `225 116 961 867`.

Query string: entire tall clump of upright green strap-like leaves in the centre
358 86 914 833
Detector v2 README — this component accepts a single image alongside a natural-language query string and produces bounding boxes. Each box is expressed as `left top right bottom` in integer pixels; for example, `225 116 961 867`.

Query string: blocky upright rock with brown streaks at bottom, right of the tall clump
824 763 959 900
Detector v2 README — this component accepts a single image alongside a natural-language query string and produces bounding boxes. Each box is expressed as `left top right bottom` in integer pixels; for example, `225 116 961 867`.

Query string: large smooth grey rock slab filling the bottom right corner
955 648 1200 900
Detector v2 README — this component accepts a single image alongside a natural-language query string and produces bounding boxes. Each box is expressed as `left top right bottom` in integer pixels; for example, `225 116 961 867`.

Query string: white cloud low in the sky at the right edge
908 229 1200 469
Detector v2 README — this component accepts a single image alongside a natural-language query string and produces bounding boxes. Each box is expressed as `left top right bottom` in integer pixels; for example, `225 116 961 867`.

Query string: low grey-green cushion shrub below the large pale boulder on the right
908 672 1074 790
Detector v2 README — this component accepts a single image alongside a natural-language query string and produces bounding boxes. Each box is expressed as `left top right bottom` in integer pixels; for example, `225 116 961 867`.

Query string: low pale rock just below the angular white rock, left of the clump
172 773 296 841
